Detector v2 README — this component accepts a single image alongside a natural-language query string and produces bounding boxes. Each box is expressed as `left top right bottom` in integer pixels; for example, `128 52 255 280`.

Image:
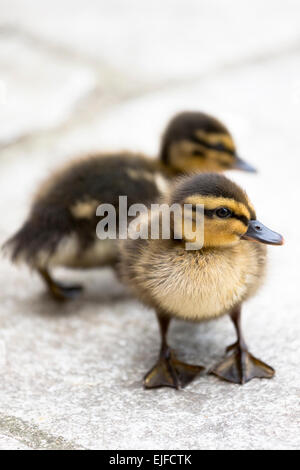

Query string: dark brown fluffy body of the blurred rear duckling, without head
4 154 165 267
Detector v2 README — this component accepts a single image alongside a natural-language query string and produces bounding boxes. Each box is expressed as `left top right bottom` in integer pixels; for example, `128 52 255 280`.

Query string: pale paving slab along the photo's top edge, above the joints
1 0 299 83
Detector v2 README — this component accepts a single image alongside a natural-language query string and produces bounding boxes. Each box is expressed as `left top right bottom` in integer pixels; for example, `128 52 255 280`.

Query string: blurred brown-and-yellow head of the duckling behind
161 112 256 173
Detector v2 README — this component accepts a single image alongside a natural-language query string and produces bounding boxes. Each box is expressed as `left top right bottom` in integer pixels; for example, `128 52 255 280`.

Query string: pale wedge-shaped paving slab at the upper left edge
0 34 95 145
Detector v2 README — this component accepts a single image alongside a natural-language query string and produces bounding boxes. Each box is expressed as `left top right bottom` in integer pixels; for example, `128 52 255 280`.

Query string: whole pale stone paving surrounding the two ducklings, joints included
0 0 300 449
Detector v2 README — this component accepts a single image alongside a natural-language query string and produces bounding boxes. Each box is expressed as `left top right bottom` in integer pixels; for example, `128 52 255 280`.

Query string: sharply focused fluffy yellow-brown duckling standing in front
119 173 283 388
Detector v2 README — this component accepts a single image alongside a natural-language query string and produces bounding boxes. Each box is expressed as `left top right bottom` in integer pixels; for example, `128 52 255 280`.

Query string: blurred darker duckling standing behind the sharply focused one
4 112 254 300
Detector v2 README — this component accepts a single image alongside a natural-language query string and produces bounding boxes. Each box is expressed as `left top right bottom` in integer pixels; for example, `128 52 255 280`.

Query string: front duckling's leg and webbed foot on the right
211 306 275 385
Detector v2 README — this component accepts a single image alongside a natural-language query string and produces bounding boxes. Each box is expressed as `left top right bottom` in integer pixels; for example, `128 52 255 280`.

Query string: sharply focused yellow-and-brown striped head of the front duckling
171 173 283 248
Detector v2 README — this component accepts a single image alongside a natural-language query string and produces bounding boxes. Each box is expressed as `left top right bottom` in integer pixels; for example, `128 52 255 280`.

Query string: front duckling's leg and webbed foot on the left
144 314 204 389
